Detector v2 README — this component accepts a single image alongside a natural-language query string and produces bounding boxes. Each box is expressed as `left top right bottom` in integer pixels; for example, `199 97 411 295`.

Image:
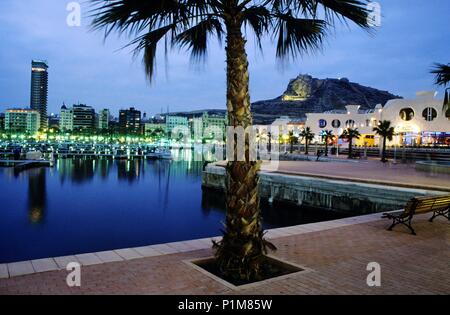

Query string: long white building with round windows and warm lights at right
306 92 450 146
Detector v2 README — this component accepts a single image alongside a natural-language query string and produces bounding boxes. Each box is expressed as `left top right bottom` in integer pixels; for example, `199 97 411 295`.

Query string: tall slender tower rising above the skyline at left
30 60 48 129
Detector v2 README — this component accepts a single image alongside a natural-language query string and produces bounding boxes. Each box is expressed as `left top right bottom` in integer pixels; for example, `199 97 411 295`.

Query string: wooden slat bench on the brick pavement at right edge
383 195 450 235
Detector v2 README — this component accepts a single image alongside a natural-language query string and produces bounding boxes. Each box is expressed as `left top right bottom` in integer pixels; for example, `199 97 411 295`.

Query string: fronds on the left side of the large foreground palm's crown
91 0 222 81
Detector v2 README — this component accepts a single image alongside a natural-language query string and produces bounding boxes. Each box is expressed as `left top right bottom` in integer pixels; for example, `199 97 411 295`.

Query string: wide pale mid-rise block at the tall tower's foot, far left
5 108 40 133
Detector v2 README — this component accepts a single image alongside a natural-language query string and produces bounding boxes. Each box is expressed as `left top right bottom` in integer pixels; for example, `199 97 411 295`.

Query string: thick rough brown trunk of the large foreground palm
214 18 266 280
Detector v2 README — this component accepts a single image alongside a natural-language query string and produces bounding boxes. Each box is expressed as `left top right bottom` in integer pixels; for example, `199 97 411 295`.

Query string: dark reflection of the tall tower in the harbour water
28 167 47 223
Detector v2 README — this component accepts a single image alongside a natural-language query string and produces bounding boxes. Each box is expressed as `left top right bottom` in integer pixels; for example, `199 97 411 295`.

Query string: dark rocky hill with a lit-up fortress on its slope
252 75 401 120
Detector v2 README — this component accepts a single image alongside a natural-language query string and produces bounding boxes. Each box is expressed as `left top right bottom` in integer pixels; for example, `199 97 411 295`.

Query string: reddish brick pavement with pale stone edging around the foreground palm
0 214 450 294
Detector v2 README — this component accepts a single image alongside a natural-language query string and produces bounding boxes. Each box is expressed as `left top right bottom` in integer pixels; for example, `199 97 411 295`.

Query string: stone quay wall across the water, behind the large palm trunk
202 165 440 214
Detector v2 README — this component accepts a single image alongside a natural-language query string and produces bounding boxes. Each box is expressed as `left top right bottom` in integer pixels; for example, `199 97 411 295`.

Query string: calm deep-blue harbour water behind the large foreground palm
0 153 350 263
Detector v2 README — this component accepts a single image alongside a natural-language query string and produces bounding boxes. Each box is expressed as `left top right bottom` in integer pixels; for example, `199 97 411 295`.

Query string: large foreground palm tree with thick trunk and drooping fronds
91 0 370 280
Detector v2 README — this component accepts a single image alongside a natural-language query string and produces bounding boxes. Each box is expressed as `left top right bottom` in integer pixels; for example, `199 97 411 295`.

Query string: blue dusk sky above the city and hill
0 0 450 114
